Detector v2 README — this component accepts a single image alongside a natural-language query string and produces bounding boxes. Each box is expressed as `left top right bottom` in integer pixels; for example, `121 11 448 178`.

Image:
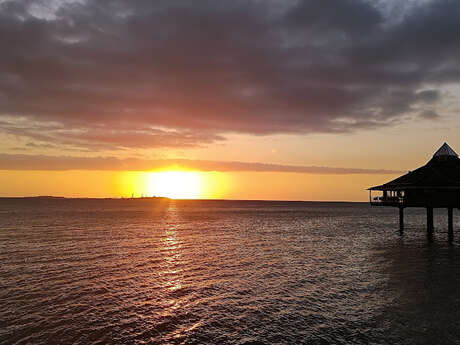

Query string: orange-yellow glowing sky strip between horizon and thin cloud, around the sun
0 167 398 202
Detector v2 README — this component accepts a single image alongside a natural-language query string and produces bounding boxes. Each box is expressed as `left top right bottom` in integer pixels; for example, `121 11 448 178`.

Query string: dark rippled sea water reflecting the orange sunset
0 200 460 344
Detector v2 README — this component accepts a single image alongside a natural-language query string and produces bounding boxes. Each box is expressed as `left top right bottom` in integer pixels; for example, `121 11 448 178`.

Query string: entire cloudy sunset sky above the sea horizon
0 0 460 201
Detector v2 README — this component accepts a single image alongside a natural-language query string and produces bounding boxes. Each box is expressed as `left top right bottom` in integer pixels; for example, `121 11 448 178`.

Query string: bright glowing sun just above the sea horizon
147 171 203 199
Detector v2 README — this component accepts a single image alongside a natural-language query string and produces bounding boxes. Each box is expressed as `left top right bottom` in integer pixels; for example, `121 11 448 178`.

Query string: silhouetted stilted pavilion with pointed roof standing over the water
368 143 460 241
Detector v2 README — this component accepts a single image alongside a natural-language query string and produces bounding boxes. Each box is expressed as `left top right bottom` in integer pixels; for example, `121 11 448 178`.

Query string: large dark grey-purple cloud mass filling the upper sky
0 0 460 148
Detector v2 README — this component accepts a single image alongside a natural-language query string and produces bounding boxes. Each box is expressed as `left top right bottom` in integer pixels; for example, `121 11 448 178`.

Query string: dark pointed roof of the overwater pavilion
369 143 460 190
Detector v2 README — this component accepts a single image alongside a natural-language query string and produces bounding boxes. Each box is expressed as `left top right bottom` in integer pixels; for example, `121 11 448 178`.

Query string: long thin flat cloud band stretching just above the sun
0 154 400 175
